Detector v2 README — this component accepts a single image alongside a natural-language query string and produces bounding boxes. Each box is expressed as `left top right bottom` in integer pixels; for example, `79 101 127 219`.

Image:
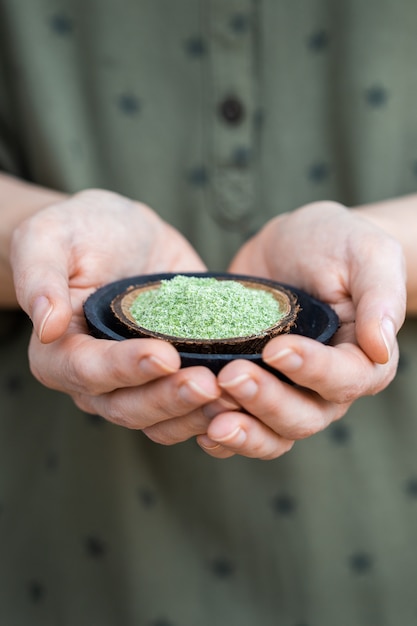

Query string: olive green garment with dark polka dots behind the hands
0 0 417 626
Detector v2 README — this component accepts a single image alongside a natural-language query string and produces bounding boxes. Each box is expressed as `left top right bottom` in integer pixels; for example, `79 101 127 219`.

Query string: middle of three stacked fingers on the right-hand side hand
218 361 347 440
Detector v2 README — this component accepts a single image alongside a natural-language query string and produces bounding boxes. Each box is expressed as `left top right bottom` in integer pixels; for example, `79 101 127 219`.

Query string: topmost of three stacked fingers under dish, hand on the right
263 335 398 404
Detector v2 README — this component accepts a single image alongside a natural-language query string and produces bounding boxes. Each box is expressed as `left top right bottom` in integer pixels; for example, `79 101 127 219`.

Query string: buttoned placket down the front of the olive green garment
205 0 257 231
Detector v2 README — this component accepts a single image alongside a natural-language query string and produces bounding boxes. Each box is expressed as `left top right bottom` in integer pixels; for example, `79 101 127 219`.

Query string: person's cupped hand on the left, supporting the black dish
11 190 235 444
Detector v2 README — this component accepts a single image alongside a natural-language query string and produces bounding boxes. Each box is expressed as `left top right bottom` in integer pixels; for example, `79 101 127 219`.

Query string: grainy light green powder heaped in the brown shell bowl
130 275 283 339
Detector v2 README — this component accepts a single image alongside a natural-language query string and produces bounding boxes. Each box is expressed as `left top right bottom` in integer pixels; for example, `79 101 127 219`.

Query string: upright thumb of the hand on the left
11 219 72 343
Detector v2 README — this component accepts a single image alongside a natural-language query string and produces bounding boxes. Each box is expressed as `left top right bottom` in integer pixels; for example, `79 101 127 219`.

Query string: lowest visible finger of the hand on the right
197 411 294 460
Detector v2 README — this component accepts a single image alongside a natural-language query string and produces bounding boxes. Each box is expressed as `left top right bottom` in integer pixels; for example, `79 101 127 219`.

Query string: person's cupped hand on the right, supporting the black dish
198 202 406 459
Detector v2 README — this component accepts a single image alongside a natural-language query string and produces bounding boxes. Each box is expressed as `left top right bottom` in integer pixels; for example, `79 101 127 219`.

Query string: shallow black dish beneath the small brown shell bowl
84 272 339 380
